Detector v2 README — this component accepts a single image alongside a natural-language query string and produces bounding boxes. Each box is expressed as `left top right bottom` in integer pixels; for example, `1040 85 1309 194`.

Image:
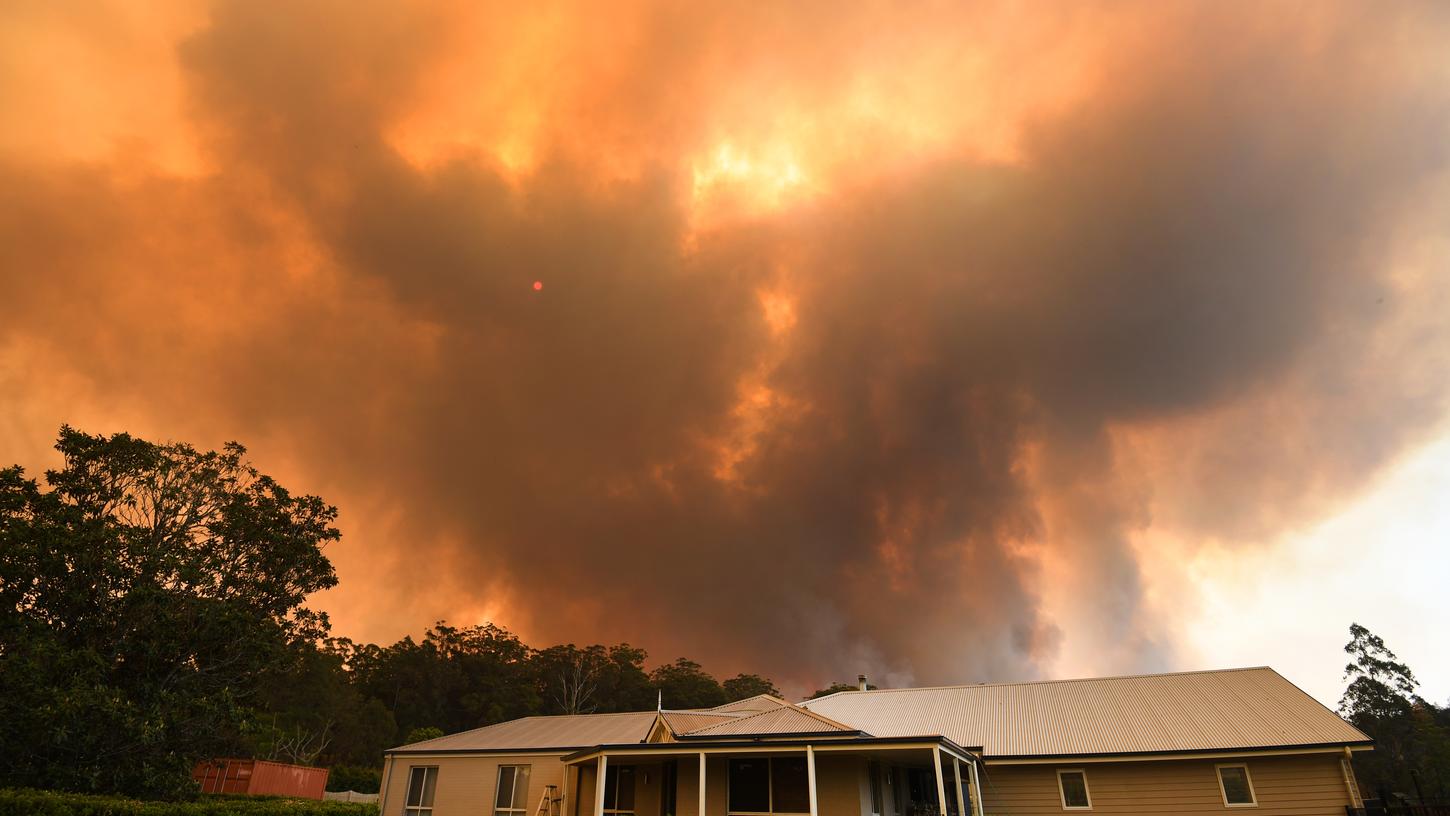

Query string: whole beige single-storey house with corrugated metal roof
380 667 1370 816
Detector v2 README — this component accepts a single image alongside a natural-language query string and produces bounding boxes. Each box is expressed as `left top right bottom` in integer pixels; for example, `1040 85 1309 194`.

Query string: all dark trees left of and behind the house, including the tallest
0 428 779 797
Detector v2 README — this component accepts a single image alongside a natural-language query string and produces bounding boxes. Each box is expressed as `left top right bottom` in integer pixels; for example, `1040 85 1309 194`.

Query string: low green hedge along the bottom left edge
0 788 377 816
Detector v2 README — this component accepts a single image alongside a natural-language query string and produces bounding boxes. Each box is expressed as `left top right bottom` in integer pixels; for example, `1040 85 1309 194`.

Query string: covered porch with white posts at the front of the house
561 736 983 816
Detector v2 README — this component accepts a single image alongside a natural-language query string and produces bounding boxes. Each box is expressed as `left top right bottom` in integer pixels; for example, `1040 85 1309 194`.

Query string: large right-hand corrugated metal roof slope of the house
802 667 1369 757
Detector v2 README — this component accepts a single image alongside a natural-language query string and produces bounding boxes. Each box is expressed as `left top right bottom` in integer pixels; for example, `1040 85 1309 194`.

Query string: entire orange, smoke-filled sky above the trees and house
0 0 1450 700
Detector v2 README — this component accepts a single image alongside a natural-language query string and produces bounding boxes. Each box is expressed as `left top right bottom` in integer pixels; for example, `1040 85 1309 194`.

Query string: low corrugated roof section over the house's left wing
393 712 655 752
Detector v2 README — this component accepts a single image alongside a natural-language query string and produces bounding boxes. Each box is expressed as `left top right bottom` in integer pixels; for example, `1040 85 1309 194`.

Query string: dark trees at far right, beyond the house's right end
1340 623 1450 799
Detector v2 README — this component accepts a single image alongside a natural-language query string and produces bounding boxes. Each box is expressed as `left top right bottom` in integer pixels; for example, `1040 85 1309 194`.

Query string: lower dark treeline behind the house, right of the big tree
251 622 780 767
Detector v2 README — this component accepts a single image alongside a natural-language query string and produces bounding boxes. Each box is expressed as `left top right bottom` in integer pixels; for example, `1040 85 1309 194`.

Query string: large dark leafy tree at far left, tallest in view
0 428 338 796
